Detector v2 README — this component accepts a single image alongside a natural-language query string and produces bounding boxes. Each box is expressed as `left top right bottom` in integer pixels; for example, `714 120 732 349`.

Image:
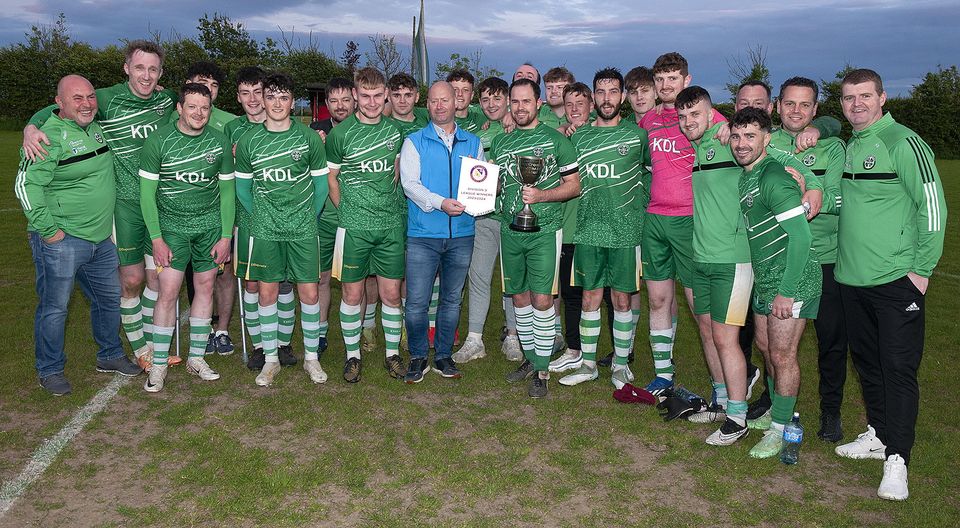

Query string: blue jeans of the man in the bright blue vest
404 236 473 361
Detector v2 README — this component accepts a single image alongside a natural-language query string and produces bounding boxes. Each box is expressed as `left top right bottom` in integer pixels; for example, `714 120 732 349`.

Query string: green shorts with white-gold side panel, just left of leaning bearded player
690 262 753 326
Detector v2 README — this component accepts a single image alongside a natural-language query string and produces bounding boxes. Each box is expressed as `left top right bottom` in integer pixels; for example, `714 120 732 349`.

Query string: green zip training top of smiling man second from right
770 128 846 264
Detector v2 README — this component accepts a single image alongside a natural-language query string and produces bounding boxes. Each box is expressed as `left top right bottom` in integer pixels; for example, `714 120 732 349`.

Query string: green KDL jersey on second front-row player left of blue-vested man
236 120 329 241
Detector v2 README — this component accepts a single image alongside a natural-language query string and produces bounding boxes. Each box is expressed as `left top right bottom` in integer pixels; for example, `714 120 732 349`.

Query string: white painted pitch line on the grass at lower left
0 374 133 519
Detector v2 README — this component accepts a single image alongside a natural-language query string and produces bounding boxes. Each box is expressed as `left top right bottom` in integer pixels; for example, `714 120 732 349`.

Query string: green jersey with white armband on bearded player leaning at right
740 155 822 300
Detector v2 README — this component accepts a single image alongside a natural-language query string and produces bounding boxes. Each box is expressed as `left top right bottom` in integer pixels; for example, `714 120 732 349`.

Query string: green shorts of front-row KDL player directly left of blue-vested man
332 225 407 282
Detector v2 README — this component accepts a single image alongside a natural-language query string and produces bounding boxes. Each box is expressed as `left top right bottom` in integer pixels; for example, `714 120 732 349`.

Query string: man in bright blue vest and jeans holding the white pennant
400 81 484 383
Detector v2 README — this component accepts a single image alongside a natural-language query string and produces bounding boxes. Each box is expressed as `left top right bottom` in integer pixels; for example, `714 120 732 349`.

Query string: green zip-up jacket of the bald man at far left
14 113 117 243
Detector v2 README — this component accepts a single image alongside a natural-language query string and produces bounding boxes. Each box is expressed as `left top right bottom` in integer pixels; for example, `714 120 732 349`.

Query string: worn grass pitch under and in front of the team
0 132 960 527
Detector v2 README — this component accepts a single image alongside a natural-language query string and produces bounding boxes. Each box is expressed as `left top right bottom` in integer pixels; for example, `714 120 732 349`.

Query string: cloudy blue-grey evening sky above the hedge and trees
0 0 960 101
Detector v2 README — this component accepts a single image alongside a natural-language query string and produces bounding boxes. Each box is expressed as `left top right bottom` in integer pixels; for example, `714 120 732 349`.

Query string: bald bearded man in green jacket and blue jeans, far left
15 75 142 396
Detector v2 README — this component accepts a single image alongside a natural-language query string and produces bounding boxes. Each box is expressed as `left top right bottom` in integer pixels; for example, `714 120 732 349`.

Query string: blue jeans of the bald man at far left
30 232 125 378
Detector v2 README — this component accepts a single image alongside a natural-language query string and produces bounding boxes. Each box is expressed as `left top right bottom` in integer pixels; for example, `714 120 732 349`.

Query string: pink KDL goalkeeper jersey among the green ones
640 108 727 216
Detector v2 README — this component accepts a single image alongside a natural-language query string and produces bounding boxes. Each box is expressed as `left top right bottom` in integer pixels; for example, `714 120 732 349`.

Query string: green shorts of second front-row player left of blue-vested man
244 236 320 283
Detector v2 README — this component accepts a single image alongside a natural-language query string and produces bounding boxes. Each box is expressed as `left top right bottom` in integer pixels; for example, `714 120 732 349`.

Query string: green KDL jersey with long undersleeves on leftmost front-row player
140 122 235 239
